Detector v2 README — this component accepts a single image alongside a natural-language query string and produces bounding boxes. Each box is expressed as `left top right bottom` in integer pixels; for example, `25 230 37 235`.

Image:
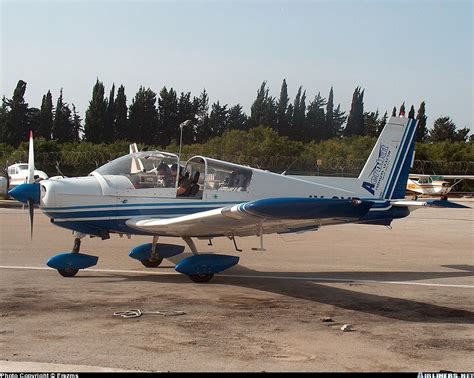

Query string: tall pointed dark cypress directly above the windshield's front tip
84 79 107 143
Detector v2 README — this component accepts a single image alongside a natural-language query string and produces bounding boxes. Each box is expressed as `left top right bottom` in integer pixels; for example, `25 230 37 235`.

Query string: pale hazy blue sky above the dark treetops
0 0 474 131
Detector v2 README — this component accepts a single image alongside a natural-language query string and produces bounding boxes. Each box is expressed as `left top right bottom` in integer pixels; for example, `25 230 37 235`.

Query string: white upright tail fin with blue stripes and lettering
359 117 417 199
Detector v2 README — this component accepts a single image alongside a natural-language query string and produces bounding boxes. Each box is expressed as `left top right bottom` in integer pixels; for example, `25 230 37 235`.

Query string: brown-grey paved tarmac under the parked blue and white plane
0 202 474 372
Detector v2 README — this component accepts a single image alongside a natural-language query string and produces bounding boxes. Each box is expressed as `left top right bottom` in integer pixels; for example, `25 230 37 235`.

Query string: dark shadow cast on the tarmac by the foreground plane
88 252 474 324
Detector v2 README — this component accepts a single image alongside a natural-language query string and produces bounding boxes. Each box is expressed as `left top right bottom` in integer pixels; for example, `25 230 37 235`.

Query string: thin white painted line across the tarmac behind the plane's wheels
0 265 474 289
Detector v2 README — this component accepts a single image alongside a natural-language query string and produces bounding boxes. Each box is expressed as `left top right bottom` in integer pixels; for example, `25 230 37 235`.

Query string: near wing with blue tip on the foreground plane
126 198 373 237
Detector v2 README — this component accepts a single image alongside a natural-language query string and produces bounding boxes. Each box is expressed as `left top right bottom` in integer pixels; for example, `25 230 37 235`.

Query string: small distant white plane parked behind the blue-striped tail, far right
407 173 474 199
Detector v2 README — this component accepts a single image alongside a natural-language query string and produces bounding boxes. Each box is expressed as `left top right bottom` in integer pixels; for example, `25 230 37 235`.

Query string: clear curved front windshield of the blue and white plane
94 151 178 188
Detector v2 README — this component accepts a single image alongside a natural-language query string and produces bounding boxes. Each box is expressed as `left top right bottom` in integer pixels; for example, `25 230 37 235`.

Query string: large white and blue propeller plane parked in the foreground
9 117 465 282
